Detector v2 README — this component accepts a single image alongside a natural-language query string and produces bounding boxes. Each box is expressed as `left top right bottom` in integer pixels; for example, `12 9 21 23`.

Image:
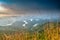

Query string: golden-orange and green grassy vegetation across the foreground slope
0 22 60 40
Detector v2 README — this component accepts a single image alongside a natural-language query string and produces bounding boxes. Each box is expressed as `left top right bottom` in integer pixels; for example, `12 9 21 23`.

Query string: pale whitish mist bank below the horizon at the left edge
0 17 16 26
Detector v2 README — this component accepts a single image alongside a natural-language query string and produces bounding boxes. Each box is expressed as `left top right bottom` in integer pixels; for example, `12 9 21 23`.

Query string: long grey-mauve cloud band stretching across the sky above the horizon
0 3 60 18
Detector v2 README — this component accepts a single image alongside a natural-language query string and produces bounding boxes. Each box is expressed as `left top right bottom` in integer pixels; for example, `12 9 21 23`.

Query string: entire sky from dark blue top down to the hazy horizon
0 0 60 16
